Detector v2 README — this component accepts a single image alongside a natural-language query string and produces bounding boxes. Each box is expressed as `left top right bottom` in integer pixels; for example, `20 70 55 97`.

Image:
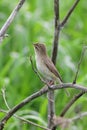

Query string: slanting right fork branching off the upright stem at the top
60 0 80 27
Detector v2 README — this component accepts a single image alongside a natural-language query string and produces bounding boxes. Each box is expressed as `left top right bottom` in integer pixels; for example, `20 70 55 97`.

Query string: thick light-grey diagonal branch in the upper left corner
0 0 25 42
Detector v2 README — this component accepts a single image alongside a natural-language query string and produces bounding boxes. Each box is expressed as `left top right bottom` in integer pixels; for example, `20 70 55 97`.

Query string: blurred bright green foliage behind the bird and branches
0 0 87 130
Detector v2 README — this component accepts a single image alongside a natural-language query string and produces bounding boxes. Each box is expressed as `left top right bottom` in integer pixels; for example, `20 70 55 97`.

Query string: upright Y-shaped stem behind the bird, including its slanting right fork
48 0 80 130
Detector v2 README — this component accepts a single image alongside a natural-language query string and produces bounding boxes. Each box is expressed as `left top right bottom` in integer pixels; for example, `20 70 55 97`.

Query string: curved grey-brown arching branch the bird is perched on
0 83 87 130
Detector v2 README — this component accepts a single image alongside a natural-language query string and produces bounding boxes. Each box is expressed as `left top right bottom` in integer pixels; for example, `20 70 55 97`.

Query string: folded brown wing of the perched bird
45 57 62 81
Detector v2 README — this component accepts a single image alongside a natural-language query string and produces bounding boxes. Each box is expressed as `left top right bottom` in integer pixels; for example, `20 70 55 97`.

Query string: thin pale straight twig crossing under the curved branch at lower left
0 109 50 130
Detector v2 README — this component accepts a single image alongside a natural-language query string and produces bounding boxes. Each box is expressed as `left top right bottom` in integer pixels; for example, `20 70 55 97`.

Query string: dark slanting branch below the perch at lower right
60 91 85 117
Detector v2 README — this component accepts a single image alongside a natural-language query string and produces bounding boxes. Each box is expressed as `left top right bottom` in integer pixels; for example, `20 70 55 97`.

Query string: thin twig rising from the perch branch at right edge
73 46 87 84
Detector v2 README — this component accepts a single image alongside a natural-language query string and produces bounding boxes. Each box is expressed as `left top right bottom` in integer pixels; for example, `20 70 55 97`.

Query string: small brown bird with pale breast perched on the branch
34 43 62 84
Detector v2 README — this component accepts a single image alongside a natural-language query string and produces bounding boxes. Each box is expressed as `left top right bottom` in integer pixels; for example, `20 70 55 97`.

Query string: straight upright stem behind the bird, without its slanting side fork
48 0 60 130
